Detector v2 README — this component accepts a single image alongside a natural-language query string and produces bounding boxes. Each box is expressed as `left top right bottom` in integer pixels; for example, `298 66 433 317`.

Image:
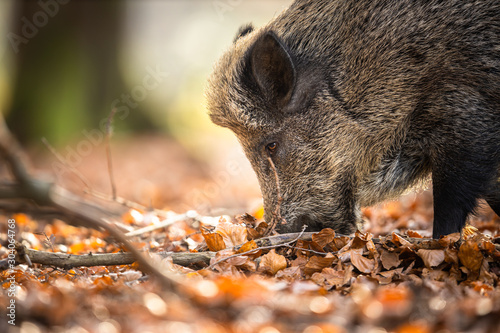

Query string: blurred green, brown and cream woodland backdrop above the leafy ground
0 0 290 158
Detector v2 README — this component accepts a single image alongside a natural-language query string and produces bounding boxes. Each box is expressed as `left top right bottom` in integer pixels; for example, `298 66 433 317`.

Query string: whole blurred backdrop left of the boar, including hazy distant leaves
0 0 291 214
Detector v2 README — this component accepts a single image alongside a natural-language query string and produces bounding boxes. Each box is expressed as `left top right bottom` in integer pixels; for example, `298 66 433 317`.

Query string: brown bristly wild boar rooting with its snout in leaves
207 0 500 237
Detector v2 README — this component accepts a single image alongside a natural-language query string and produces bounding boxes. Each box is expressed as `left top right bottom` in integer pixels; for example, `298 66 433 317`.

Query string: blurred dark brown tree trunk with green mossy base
7 0 124 144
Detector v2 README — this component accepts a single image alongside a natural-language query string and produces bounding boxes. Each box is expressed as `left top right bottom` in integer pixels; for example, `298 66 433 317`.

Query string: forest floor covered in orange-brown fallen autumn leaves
0 137 500 333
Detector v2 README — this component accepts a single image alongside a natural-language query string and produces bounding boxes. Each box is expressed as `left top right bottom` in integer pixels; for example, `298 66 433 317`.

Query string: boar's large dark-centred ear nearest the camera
248 32 296 108
